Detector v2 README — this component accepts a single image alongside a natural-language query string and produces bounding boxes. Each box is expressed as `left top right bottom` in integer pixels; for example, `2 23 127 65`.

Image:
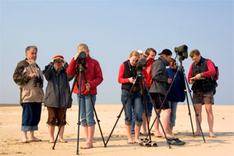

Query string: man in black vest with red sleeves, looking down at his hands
188 49 216 137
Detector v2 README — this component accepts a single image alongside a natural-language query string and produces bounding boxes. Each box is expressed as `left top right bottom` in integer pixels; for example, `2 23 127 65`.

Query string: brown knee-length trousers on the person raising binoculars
47 107 67 126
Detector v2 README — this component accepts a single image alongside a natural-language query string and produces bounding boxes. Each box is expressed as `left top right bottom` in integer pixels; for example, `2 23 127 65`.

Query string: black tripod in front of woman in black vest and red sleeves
106 71 170 148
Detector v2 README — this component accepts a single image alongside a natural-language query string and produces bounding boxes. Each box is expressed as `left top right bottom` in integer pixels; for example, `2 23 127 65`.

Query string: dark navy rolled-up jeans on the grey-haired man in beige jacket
21 102 41 131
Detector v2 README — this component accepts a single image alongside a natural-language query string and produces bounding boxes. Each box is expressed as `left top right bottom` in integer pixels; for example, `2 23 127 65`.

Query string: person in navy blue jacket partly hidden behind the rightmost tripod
167 58 185 134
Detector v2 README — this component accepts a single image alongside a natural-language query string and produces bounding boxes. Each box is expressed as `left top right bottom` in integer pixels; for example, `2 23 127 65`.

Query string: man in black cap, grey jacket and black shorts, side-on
150 49 172 137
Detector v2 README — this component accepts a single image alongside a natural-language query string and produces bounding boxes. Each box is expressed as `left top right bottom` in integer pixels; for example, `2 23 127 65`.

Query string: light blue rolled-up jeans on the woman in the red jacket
77 95 96 126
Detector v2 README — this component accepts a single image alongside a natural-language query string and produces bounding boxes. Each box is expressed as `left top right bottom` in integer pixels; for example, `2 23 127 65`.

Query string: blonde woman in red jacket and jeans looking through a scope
67 44 103 149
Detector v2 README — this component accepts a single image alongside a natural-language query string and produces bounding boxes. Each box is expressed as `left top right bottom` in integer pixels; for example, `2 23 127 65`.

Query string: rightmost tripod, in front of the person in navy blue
150 55 206 142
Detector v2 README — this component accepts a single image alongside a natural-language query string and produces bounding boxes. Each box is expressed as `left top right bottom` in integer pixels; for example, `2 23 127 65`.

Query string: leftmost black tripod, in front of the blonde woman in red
52 62 106 155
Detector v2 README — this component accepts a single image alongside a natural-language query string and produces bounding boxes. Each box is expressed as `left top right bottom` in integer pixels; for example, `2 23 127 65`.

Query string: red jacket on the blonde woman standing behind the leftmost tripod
67 56 103 95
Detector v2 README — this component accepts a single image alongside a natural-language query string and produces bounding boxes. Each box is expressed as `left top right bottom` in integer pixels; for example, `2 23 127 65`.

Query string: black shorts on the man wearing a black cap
151 93 170 110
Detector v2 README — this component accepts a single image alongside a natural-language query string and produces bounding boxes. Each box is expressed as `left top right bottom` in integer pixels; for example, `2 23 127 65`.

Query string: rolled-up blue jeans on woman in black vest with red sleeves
121 89 143 126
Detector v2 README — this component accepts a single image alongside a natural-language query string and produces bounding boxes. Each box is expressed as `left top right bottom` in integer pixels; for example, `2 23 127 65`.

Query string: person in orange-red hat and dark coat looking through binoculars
43 55 72 143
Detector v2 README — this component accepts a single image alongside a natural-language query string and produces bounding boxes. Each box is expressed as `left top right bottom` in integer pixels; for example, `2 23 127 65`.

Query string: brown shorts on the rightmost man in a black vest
193 91 214 105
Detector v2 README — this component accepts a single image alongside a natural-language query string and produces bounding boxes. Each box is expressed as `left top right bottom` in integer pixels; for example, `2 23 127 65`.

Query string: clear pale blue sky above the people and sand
0 0 234 105
